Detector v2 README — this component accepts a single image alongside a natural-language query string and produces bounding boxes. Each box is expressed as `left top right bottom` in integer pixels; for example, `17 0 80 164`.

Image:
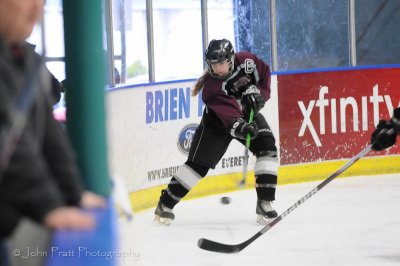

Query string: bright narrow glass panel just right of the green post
113 0 149 83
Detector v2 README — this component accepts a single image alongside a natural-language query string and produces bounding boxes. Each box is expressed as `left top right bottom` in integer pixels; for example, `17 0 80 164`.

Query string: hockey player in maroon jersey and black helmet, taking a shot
155 39 278 225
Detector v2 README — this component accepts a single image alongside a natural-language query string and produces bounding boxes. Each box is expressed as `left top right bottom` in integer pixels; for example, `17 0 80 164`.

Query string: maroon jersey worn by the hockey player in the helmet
202 52 271 129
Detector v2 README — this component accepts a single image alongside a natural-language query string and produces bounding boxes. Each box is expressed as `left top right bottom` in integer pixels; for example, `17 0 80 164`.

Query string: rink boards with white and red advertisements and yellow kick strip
107 67 400 211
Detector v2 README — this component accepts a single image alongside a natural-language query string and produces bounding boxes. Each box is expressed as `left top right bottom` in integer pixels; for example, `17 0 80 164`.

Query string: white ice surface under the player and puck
118 174 400 266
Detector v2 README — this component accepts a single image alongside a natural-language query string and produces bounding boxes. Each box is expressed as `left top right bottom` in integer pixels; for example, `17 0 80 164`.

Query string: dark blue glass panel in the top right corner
355 0 400 65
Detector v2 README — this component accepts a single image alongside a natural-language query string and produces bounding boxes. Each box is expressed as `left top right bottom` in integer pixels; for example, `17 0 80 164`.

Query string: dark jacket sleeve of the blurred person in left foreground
0 84 83 233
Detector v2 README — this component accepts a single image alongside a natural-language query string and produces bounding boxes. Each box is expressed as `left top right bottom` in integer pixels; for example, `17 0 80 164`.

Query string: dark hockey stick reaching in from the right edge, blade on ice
197 144 372 253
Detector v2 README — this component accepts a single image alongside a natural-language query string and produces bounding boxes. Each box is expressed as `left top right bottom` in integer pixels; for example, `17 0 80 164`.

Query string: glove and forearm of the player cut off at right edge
371 107 400 151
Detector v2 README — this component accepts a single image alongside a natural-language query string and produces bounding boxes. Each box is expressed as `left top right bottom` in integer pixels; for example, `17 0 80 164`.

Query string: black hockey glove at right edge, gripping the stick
371 120 397 151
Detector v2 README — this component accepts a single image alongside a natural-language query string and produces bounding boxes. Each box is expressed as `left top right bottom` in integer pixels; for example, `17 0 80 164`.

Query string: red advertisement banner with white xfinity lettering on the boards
277 68 400 165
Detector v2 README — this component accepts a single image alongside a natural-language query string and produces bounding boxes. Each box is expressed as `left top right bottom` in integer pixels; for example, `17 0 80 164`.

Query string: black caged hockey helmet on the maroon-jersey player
204 39 235 79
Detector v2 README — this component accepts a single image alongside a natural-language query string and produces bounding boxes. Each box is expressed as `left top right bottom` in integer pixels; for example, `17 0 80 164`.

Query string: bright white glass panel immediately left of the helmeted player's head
153 0 203 81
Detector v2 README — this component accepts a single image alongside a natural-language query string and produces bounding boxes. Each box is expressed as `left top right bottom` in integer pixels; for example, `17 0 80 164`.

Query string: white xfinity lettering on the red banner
297 84 399 147
